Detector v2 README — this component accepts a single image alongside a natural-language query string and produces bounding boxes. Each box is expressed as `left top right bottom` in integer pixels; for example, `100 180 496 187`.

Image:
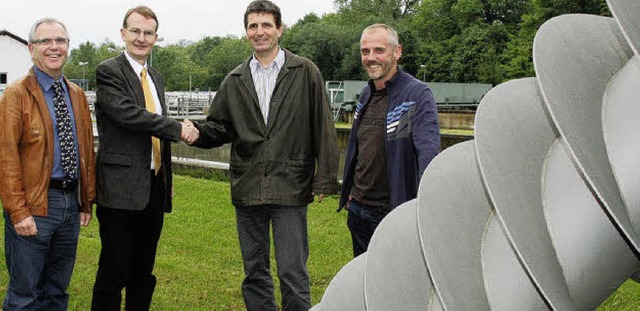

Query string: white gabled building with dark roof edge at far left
0 30 32 93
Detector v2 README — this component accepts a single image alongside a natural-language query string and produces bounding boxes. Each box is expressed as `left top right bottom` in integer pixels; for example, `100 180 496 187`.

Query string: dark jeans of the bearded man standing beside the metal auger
347 199 389 257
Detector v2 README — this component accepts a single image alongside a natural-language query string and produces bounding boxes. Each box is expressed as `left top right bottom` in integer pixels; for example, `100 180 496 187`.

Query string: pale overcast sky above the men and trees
0 0 335 47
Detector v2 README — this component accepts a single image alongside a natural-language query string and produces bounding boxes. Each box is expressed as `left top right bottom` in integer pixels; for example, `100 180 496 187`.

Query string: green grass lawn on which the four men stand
0 176 640 311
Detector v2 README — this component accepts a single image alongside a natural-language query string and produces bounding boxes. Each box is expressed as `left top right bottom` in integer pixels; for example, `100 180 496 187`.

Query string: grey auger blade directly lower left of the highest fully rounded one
475 78 575 310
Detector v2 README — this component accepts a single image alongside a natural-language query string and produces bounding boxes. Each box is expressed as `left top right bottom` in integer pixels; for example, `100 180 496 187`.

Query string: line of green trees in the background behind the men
64 0 611 91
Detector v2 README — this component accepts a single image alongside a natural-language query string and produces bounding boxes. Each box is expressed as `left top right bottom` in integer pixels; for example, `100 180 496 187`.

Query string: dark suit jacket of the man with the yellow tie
96 54 182 212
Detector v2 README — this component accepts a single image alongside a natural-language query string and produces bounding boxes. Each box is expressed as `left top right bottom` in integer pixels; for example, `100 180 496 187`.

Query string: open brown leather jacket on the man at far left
0 69 95 224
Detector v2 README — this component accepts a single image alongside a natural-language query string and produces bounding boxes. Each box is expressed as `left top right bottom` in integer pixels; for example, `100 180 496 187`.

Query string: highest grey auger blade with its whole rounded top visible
533 14 640 259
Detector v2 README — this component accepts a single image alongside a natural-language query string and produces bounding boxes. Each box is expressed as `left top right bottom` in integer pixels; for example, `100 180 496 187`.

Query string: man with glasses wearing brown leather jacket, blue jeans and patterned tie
0 18 95 311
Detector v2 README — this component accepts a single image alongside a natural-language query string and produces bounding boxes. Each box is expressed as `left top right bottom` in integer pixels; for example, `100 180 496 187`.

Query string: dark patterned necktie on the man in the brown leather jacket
53 81 78 182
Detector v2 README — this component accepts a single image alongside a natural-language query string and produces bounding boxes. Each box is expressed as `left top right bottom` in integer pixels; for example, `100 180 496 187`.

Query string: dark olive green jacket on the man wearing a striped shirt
194 50 339 206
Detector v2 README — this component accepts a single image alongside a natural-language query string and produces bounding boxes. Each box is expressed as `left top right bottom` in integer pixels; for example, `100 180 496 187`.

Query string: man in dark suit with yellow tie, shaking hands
91 6 197 310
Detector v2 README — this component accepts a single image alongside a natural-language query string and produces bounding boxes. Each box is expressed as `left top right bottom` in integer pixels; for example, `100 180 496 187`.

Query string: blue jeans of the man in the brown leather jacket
2 189 80 311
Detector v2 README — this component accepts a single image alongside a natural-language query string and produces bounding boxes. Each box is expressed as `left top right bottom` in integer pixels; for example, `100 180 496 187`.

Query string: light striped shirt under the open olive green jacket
249 49 284 124
